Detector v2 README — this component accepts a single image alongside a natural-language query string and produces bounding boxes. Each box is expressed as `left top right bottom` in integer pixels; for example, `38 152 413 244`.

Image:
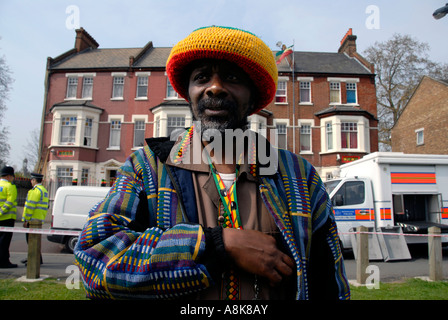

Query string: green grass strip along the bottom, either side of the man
0 278 448 300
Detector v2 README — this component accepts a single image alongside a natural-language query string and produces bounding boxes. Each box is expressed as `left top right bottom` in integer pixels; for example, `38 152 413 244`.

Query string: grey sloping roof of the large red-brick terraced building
50 45 372 75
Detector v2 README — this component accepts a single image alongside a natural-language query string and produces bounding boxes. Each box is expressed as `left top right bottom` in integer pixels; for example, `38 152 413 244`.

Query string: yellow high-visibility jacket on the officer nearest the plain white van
22 184 48 222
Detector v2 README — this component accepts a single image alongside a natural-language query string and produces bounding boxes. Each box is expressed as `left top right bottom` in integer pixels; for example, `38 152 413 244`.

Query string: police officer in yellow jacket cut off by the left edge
0 166 17 268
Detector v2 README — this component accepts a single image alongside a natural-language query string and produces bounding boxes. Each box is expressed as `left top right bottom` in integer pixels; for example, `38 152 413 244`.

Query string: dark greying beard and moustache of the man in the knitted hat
190 97 249 136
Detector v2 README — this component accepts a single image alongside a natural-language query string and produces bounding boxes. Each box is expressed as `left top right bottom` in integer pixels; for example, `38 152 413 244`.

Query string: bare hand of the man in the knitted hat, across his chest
222 228 295 285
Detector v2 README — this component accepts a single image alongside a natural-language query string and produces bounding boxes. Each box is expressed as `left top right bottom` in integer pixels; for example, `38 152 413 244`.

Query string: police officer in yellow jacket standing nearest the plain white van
21 173 48 264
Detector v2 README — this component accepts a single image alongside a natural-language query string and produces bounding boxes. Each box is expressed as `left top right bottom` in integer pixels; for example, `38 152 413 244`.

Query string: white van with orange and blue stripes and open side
325 152 448 249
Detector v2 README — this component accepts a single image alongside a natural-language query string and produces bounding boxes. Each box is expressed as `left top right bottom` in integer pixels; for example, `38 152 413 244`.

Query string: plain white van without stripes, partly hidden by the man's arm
47 186 110 252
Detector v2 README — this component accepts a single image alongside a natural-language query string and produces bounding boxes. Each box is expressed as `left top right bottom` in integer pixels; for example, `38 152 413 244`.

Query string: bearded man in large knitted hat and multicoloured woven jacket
75 26 349 299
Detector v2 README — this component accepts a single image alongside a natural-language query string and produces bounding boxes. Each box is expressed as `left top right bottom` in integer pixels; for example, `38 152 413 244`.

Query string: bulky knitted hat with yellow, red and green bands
166 26 278 113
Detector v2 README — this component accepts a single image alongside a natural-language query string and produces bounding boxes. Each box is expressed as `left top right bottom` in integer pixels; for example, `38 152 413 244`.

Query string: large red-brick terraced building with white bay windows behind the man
39 28 378 196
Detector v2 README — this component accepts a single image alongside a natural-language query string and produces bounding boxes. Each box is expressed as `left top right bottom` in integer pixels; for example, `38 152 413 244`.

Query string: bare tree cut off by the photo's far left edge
0 40 13 165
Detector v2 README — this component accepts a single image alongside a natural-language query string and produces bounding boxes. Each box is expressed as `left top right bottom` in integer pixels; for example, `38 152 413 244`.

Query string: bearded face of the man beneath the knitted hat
188 60 254 133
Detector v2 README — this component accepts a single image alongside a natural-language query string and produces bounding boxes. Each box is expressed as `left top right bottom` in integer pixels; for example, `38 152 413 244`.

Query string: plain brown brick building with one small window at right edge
391 76 448 154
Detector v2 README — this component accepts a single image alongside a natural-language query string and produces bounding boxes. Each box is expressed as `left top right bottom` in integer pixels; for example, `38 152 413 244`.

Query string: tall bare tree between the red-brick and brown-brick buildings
363 34 448 151
